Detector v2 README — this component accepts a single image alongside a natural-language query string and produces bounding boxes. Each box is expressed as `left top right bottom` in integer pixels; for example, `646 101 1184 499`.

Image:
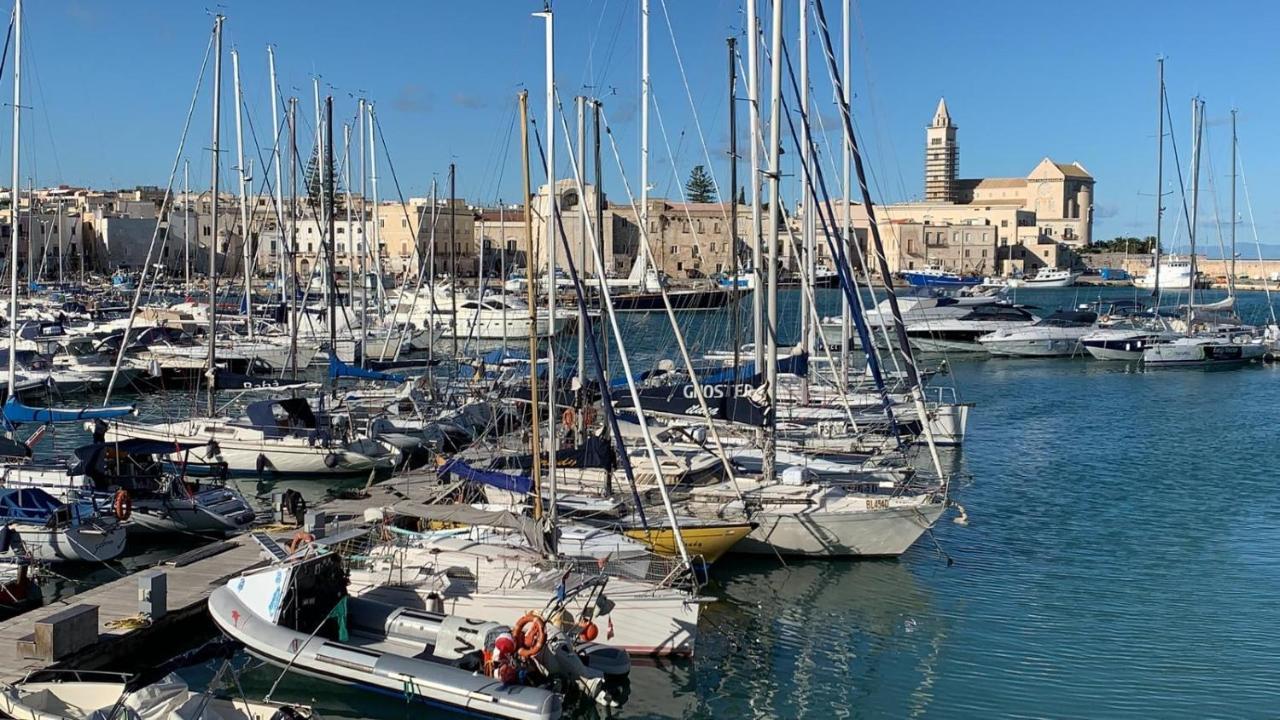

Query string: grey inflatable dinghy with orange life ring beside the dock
209 551 630 720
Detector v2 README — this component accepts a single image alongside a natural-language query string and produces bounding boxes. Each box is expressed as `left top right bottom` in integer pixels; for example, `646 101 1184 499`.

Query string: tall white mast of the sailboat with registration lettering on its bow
756 0 782 482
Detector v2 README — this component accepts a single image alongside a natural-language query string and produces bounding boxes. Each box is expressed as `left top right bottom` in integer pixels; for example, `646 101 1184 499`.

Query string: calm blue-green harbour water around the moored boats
77 284 1280 719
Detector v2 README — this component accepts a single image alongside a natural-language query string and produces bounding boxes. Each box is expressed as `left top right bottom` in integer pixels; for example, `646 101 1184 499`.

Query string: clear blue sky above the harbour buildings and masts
0 0 1280 256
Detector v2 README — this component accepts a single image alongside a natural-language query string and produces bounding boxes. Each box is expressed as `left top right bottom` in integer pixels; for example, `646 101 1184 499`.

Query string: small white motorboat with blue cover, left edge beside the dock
0 488 125 562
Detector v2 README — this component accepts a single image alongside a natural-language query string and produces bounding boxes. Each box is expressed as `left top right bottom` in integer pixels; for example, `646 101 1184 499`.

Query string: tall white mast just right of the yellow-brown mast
535 7 560 527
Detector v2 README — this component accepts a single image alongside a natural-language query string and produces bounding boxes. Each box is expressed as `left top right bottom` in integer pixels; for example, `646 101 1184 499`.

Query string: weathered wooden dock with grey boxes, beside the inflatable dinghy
0 473 435 683
